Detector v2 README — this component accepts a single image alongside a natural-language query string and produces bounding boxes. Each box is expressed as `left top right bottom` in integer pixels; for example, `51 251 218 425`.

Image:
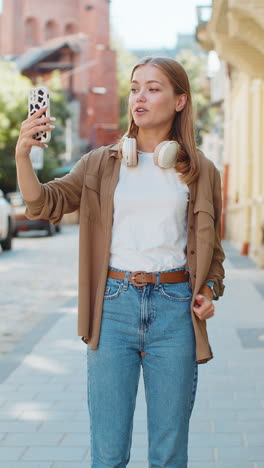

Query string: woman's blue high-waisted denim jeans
87 267 198 468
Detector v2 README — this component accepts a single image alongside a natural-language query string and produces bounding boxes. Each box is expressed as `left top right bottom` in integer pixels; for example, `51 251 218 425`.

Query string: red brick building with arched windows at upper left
0 0 119 159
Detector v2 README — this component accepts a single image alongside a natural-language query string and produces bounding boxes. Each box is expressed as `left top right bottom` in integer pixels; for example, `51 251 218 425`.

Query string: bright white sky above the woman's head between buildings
0 0 211 49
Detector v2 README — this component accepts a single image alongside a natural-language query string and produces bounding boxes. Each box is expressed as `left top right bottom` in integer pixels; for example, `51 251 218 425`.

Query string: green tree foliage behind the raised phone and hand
0 61 70 193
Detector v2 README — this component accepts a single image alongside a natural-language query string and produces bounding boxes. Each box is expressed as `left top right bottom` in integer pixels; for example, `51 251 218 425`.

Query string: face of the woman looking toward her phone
129 64 179 131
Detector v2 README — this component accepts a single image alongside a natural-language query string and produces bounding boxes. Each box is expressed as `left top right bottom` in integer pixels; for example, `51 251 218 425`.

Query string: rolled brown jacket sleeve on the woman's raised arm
24 155 87 224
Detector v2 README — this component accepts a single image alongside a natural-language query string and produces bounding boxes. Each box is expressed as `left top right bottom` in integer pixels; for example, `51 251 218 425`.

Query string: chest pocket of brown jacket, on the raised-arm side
82 174 100 222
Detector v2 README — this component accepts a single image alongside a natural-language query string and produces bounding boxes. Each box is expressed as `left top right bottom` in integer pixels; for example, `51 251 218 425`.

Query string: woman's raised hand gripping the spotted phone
16 106 56 163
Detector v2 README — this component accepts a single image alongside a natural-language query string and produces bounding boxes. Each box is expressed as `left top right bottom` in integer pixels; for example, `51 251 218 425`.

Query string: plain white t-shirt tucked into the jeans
109 151 189 272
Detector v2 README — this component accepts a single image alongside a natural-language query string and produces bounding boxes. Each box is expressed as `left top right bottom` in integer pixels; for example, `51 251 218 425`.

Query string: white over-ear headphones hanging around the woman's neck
121 136 179 169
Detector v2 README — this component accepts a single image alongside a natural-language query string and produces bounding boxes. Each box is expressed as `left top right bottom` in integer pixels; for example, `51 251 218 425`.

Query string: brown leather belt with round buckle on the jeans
108 270 189 287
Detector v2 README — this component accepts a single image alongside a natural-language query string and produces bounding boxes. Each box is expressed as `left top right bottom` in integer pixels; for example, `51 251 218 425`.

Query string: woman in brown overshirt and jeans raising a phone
16 57 225 468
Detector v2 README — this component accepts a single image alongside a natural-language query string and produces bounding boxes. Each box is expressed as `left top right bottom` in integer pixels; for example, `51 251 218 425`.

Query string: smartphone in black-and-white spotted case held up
28 86 51 143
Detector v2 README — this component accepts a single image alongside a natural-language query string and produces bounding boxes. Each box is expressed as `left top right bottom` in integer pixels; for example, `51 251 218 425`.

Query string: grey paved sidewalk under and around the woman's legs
0 243 264 468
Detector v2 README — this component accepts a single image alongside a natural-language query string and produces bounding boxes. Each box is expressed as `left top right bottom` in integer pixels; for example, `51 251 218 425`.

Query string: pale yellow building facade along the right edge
196 0 264 267
